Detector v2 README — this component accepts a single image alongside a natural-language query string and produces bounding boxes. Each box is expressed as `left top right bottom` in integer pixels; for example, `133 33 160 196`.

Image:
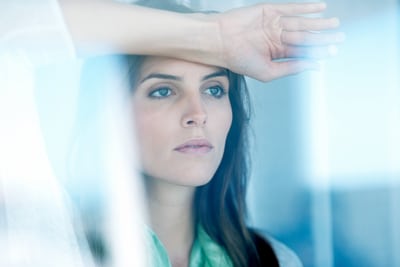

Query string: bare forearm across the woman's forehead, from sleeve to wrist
59 0 224 65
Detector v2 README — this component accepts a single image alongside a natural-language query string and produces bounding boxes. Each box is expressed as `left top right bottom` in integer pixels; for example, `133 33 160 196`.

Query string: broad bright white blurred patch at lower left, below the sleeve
0 51 91 267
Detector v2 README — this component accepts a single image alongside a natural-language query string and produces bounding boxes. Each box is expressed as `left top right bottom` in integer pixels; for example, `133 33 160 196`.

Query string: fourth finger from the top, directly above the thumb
284 45 338 59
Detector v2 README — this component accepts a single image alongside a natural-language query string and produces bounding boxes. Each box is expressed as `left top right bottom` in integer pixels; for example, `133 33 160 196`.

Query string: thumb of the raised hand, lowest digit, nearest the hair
266 60 320 81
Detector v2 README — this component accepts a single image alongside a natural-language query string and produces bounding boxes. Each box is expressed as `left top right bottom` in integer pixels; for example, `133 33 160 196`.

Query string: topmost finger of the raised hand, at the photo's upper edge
274 2 326 16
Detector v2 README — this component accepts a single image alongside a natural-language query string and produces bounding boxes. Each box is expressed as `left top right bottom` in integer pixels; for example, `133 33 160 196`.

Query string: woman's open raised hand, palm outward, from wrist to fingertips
215 3 344 81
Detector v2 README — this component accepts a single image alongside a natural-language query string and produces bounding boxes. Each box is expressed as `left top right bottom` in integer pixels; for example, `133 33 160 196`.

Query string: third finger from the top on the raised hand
281 31 344 46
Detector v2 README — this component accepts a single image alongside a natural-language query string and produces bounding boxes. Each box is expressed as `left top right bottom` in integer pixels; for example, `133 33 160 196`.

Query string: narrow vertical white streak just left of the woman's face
99 64 147 267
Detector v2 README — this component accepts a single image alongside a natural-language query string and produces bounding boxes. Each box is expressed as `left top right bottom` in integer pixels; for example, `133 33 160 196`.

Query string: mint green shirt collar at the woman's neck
147 227 233 267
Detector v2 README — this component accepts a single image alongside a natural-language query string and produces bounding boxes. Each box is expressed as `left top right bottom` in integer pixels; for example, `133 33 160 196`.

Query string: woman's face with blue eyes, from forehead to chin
133 57 232 186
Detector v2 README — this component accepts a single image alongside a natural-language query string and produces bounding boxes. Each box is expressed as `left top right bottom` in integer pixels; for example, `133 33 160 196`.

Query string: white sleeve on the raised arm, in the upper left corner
0 0 75 66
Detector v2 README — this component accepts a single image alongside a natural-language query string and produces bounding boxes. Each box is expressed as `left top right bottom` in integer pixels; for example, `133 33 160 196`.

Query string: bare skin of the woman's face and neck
133 57 232 266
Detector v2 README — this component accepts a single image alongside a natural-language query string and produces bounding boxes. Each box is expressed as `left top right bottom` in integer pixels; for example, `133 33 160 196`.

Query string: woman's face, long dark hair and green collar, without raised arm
76 1 342 266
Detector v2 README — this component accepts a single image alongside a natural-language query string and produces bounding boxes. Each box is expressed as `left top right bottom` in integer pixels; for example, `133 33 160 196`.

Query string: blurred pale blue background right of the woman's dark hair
188 0 400 267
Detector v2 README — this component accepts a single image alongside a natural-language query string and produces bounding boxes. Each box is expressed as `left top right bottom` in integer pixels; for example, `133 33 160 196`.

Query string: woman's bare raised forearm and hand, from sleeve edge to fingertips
59 0 342 81
